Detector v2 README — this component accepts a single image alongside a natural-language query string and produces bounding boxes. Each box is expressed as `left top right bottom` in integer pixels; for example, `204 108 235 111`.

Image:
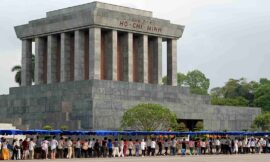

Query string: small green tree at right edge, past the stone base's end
253 112 270 131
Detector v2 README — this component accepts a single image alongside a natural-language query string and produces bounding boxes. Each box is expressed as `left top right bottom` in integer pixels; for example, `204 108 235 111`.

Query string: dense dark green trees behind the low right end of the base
210 78 270 111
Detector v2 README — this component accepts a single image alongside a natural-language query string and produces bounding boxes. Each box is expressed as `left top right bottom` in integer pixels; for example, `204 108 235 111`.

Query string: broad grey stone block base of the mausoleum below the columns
0 80 261 130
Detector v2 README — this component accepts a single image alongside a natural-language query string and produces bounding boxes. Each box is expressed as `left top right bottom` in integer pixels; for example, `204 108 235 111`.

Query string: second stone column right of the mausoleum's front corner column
123 33 133 82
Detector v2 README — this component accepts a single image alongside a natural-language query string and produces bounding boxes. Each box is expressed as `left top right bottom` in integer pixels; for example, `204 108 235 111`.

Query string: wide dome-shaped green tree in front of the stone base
121 103 177 131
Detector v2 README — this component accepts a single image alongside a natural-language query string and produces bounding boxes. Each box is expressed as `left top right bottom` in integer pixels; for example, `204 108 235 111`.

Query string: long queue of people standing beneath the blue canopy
0 136 270 160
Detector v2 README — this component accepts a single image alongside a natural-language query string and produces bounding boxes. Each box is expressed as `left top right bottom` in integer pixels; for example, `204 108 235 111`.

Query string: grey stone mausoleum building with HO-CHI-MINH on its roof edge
0 2 261 130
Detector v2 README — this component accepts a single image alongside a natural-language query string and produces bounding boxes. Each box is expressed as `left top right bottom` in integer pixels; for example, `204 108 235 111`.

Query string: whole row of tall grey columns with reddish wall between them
21 28 177 86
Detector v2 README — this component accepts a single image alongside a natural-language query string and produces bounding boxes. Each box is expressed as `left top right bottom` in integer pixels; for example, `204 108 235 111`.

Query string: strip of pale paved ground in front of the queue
3 154 270 162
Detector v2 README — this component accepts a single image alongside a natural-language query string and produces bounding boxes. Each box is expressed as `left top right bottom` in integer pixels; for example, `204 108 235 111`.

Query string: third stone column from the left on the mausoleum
47 35 57 83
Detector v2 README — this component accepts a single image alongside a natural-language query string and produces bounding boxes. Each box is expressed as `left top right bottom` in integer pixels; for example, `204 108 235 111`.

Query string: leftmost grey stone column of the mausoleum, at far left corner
21 39 32 86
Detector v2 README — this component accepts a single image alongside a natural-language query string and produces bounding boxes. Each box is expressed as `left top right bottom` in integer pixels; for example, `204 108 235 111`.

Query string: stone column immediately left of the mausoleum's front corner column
74 30 84 80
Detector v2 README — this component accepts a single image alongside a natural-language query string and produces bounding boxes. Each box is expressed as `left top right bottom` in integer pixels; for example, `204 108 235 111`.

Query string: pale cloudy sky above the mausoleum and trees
0 0 270 94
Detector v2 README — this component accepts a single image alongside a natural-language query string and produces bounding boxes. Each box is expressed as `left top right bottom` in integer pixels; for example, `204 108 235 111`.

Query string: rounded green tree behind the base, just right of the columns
185 70 210 95
